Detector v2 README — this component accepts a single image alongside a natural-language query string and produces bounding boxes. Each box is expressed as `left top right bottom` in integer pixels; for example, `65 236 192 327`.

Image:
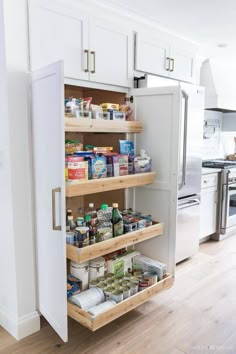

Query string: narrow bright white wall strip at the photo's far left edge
0 0 17 330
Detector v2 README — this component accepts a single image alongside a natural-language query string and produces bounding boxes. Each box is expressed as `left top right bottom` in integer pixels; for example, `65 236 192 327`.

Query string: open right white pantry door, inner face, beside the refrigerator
132 87 181 274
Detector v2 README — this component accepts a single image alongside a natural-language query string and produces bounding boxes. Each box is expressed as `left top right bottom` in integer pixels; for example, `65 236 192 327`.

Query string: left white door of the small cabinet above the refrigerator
135 33 170 76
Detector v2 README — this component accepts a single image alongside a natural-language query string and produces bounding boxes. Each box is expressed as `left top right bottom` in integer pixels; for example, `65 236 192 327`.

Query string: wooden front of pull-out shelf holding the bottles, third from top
66 223 163 263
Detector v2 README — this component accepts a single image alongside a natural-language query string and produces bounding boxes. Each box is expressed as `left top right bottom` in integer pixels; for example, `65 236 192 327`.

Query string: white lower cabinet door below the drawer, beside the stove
200 188 217 239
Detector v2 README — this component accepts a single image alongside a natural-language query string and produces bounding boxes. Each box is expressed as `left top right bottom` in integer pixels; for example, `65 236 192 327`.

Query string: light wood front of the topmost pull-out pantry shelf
65 117 143 133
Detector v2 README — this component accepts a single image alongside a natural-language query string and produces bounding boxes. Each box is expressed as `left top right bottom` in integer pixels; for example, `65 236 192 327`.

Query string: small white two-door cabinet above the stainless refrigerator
135 32 196 83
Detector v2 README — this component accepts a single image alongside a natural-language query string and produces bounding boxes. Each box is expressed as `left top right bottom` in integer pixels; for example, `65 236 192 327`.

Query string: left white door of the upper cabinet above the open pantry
29 0 89 80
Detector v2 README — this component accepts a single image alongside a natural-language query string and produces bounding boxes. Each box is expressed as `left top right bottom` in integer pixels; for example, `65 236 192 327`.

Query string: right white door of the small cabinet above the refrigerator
170 44 196 83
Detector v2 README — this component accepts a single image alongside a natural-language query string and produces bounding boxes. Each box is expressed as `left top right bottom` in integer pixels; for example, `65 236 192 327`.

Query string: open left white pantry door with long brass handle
32 62 68 341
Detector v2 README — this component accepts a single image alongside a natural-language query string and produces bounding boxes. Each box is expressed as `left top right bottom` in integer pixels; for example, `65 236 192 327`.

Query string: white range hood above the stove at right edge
200 57 236 113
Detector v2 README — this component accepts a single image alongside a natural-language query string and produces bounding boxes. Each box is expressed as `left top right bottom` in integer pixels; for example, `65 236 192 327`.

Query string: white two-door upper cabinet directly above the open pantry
29 0 133 87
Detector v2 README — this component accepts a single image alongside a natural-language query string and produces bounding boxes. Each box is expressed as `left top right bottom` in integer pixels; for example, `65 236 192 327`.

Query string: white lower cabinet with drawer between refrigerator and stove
200 173 218 239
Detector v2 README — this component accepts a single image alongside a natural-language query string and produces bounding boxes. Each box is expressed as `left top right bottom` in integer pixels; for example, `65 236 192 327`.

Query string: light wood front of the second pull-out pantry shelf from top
66 172 155 197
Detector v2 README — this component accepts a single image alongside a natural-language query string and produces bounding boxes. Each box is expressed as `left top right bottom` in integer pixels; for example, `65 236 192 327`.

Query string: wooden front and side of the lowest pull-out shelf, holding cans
68 274 174 332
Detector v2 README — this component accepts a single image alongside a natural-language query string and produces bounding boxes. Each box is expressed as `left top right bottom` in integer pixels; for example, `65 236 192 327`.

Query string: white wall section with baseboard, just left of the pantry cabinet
0 0 39 338
